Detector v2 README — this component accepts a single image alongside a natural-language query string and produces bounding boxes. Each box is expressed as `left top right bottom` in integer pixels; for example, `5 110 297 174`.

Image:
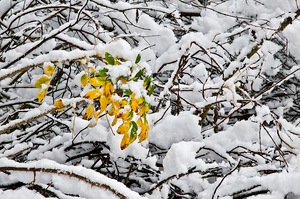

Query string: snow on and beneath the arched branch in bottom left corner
0 158 143 199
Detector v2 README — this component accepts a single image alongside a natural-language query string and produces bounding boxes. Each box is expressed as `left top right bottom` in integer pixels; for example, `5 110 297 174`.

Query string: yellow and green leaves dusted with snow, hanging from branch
35 52 154 150
